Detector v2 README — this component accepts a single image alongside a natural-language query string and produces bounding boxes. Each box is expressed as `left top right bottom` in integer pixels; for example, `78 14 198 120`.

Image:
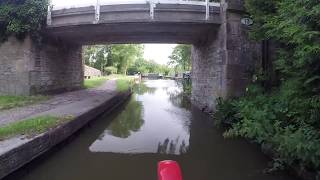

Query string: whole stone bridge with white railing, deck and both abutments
0 0 261 111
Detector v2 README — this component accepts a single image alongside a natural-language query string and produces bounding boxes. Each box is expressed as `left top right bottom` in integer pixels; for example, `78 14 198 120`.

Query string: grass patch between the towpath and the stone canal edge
0 116 72 140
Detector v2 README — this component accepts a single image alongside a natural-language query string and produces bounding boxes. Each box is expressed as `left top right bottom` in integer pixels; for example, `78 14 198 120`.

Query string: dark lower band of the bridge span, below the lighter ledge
47 22 219 45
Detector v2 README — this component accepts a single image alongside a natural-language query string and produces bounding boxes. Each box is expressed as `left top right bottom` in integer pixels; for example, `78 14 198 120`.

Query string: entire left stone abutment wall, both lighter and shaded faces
0 37 83 95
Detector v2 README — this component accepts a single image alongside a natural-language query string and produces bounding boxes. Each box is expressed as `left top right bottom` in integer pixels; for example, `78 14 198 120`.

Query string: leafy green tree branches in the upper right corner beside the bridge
246 0 320 93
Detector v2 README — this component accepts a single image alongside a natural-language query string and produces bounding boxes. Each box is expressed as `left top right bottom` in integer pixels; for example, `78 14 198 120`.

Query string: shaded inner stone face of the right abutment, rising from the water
192 28 227 112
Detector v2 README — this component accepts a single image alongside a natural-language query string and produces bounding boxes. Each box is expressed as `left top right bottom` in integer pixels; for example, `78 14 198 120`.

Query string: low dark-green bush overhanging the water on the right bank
215 81 320 170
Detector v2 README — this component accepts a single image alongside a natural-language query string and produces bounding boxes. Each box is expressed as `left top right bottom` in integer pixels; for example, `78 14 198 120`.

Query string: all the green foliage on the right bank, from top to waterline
216 0 320 174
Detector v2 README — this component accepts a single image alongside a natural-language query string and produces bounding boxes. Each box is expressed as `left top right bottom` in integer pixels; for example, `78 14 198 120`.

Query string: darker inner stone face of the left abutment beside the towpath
30 42 83 94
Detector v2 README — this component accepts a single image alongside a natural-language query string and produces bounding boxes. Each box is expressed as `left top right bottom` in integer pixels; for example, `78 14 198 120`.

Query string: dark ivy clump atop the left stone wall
0 0 48 42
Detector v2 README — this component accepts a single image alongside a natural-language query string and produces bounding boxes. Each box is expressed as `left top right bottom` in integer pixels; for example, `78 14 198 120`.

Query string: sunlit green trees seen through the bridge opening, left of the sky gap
83 44 170 75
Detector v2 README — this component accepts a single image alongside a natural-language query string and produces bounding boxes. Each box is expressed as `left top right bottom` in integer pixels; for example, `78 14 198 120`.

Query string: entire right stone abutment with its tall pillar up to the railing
192 0 261 112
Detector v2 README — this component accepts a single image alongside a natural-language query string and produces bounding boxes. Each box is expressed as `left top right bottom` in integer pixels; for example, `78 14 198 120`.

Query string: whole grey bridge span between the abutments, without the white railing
47 4 221 44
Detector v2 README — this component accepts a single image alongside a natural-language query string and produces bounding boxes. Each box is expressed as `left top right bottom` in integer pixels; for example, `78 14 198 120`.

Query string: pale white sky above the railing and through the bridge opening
51 0 176 64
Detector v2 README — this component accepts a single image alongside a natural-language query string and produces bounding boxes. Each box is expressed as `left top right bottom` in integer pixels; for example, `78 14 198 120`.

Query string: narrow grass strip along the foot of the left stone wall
0 96 48 110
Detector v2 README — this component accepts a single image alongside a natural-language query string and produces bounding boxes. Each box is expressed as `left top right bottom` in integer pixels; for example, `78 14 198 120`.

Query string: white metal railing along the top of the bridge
47 0 220 25
